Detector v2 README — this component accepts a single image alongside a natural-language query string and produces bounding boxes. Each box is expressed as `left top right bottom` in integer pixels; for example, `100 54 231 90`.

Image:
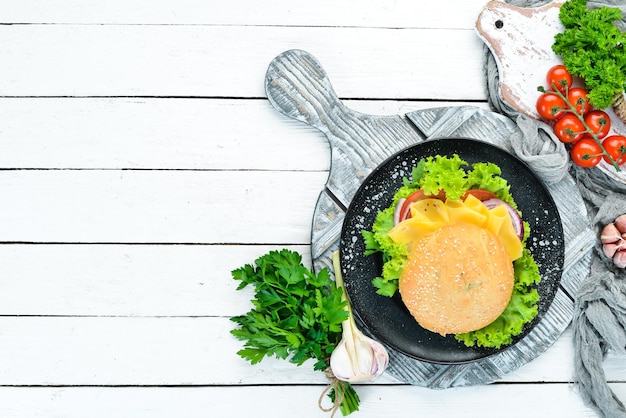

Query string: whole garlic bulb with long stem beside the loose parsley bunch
330 251 389 383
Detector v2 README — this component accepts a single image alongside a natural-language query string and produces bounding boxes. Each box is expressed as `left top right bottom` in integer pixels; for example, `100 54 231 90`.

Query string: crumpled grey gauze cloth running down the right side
483 0 626 418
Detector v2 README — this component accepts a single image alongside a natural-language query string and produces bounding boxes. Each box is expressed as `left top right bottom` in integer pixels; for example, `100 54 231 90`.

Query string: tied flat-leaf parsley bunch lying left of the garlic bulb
230 249 359 415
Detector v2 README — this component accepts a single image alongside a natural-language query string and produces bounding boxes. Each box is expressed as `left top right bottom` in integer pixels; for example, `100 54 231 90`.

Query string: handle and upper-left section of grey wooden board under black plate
265 50 422 270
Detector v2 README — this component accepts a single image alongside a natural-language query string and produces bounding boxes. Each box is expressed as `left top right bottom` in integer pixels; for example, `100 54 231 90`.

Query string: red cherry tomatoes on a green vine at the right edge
536 64 626 171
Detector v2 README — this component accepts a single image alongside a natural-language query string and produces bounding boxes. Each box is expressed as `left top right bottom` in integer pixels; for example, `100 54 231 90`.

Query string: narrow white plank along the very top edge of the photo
0 0 485 29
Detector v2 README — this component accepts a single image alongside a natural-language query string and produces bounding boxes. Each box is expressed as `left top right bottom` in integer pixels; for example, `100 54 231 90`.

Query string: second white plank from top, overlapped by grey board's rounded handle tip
0 25 485 100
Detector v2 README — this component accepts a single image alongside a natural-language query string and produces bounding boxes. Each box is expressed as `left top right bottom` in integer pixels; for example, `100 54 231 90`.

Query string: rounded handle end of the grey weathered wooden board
265 49 350 132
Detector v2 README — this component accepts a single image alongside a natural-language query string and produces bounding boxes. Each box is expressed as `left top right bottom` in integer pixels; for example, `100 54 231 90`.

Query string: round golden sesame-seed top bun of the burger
399 223 514 335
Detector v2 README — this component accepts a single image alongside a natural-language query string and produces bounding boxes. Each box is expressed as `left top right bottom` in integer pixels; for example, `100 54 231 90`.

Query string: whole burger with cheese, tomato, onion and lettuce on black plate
363 155 541 348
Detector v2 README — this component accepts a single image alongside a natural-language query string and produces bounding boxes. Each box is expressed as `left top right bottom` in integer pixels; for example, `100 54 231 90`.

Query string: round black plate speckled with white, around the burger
340 138 564 364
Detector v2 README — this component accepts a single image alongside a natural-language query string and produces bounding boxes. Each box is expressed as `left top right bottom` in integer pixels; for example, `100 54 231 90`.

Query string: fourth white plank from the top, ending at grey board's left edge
0 170 328 244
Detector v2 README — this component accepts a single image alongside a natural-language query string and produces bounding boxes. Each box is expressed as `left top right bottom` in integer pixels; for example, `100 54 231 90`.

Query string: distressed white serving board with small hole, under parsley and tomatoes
476 0 626 183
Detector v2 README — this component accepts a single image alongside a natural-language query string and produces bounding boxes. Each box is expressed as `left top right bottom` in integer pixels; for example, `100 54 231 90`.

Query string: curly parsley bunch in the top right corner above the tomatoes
552 0 626 109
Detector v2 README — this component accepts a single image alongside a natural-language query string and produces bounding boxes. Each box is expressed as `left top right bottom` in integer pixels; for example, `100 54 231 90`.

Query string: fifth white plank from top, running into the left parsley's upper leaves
0 244 311 317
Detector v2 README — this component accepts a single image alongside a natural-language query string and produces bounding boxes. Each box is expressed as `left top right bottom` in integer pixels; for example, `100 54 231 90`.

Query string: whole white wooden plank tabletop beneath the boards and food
0 0 626 418
